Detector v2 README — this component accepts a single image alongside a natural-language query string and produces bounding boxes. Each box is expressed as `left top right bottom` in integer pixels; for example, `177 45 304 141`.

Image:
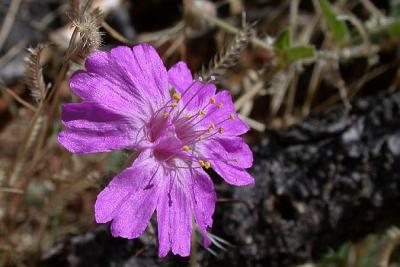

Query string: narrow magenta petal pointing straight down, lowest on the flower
157 173 192 257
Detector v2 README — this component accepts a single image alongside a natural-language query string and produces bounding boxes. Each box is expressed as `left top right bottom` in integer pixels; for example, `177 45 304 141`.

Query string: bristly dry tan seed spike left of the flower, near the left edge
25 44 49 103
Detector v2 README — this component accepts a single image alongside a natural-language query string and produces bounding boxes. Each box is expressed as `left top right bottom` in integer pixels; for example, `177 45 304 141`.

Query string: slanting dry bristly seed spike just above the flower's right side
200 24 255 80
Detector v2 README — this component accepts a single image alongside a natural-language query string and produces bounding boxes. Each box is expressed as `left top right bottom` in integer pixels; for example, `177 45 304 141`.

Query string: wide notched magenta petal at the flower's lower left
95 153 163 239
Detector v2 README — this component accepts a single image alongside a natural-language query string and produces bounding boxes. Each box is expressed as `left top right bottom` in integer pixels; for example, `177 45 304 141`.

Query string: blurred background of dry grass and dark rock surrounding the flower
0 0 400 267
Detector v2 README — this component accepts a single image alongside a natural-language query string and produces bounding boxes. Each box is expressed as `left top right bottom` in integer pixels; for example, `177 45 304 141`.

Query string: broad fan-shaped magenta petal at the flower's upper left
70 44 169 114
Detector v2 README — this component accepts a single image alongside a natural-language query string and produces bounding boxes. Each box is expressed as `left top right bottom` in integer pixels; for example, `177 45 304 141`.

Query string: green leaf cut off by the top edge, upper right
319 0 350 43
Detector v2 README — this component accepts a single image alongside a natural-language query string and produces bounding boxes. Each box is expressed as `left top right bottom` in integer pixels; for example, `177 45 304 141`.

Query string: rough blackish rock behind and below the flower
40 93 400 266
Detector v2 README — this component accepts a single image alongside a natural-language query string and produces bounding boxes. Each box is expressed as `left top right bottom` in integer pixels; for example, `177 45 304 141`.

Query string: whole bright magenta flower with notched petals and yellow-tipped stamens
58 44 254 257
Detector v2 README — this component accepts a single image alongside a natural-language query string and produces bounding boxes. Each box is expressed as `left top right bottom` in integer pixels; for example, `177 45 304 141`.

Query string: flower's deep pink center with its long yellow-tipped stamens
145 81 234 168
